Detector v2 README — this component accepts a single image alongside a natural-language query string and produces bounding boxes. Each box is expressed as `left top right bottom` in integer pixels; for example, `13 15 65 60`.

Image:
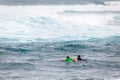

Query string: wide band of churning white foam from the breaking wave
0 5 120 41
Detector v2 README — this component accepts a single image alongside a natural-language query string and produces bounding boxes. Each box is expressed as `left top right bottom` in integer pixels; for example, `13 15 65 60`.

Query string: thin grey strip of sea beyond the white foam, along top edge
0 0 120 6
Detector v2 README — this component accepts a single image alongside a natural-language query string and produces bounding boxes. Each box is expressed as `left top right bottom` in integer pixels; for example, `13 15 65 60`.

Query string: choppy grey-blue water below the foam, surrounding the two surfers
0 36 120 80
